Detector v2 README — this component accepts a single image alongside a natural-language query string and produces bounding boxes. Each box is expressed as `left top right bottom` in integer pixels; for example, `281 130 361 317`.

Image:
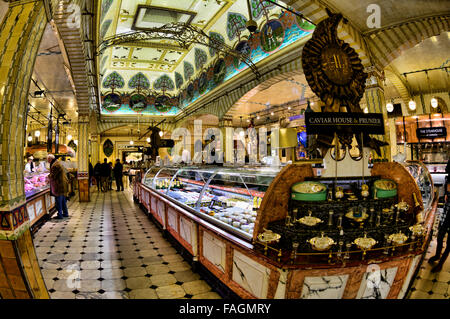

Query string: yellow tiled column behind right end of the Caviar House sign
365 67 391 161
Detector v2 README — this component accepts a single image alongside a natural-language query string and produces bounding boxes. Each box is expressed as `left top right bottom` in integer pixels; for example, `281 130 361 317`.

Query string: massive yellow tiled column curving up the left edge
0 1 49 299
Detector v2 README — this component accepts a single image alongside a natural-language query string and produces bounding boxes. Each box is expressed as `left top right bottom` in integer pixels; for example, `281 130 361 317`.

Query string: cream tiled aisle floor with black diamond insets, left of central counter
34 190 220 299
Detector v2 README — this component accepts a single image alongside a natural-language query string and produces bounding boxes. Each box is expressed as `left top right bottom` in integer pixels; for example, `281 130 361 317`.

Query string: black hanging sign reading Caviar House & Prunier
305 112 384 134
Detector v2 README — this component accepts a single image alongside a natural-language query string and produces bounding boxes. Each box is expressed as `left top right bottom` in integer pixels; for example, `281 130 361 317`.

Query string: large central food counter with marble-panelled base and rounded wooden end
134 163 437 299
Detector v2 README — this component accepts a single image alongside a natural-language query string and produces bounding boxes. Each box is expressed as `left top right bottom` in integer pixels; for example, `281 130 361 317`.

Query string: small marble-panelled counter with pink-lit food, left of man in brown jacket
24 173 55 229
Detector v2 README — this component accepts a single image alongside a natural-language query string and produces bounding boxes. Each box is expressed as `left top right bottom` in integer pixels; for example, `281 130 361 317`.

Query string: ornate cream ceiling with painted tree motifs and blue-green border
99 0 313 115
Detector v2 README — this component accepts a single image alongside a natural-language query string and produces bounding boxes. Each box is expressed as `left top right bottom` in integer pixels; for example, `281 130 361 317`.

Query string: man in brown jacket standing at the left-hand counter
47 154 69 219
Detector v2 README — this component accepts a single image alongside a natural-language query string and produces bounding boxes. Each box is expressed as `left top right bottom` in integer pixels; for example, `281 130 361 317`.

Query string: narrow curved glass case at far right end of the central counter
404 161 434 218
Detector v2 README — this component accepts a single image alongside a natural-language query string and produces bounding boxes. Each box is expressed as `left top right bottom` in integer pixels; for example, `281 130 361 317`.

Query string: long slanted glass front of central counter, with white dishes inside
143 167 281 241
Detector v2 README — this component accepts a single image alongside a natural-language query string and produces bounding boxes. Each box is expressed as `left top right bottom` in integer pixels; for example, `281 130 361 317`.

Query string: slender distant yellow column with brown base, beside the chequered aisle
77 113 90 202
